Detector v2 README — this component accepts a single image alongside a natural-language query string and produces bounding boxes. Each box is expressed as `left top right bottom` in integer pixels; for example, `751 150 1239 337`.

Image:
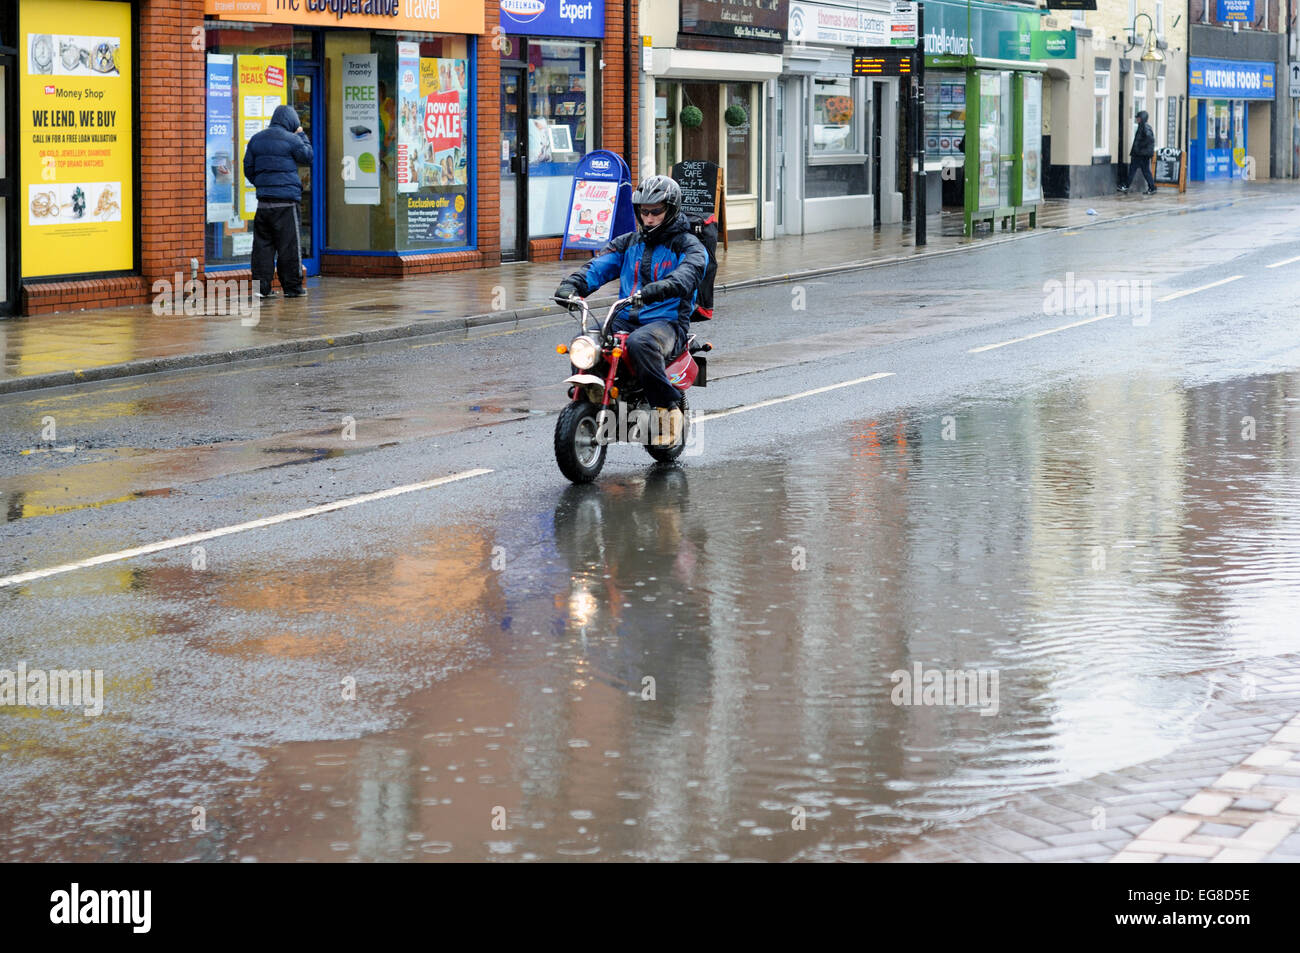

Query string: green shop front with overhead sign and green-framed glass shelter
922 0 1050 235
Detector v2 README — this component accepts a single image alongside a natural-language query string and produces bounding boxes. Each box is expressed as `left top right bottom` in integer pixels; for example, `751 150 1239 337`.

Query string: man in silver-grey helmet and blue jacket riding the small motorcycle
555 176 709 446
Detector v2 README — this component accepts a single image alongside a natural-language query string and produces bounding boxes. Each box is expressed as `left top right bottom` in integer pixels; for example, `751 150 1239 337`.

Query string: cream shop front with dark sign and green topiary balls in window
642 0 789 239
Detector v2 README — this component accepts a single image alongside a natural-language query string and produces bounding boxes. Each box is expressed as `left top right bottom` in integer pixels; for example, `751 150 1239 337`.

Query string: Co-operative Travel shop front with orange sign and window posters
204 0 484 274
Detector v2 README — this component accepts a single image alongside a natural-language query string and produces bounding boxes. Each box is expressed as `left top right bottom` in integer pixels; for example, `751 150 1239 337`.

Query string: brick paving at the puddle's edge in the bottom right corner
885 655 1300 863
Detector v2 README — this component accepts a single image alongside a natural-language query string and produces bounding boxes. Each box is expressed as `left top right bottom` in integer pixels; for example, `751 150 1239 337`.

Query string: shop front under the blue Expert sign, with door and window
499 0 606 261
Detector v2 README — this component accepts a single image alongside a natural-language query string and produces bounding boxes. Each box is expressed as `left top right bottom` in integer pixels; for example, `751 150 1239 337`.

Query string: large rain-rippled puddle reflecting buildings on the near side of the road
0 374 1300 861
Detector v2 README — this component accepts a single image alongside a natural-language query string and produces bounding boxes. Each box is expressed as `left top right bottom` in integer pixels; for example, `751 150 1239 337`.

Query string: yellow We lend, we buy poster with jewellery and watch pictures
18 0 135 277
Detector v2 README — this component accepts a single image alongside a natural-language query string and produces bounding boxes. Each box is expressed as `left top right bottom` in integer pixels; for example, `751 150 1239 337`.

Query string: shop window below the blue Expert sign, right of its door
528 40 599 238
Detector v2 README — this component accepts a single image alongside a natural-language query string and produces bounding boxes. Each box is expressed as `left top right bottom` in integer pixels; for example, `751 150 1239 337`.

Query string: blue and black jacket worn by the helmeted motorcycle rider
568 212 709 346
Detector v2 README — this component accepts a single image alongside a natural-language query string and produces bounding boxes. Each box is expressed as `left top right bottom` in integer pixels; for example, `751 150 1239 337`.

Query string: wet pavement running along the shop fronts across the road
0 181 1279 394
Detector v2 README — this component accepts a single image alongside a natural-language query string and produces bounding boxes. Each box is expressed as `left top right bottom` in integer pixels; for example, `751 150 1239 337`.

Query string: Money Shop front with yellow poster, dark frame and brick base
13 0 143 313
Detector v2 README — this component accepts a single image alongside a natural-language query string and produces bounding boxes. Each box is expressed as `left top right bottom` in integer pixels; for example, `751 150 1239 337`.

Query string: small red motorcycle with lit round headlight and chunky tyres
555 295 712 484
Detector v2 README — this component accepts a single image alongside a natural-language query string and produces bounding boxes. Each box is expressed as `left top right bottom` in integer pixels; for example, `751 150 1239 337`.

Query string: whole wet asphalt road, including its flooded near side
0 199 1300 859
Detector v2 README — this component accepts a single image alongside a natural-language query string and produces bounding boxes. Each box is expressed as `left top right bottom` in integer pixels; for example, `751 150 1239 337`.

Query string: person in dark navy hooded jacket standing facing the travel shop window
244 105 312 298
